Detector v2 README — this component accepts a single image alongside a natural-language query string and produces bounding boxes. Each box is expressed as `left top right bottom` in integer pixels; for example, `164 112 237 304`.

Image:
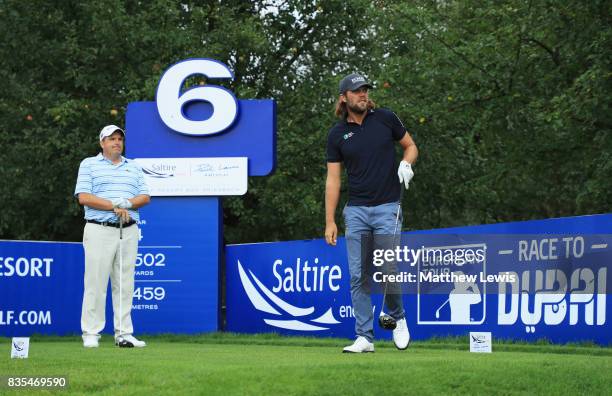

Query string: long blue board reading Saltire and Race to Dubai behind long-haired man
226 215 612 345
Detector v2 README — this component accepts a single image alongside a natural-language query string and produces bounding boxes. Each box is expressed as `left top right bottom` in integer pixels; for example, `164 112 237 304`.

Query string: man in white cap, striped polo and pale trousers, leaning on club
74 125 150 348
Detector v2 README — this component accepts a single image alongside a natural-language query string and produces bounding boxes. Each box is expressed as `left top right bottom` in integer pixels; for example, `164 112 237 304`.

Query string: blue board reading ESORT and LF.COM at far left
0 241 85 337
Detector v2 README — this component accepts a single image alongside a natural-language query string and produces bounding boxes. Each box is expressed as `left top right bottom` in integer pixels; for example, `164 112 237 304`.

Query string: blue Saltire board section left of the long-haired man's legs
226 241 352 336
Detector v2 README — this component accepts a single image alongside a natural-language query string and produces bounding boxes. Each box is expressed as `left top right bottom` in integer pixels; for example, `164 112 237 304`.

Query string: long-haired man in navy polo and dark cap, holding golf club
325 74 418 353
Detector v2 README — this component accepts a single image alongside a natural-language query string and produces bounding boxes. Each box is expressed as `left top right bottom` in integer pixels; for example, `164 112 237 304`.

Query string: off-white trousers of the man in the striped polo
81 223 139 336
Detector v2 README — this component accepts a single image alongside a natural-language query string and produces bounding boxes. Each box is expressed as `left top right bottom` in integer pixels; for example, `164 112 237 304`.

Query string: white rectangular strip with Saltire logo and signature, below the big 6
135 157 248 196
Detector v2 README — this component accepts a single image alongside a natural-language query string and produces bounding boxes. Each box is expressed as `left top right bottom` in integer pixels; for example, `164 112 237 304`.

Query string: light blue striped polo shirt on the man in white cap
74 153 149 222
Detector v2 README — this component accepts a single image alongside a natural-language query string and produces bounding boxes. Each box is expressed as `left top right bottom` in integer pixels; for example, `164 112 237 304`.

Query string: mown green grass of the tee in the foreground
0 333 612 395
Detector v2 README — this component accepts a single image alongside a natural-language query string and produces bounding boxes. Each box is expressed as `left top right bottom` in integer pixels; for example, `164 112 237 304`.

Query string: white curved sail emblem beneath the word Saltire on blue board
237 260 340 331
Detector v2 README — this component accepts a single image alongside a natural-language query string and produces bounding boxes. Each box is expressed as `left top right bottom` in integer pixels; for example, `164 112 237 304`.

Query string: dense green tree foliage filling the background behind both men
0 0 612 243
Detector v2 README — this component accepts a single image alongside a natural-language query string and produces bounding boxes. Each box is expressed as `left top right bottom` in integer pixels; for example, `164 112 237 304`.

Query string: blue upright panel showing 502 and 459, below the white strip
132 197 221 333
